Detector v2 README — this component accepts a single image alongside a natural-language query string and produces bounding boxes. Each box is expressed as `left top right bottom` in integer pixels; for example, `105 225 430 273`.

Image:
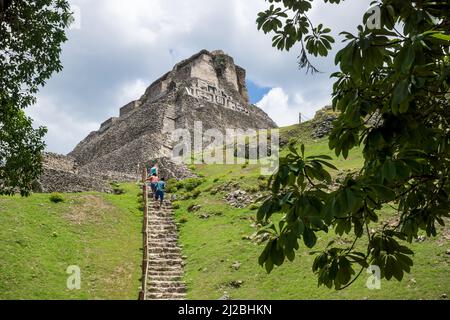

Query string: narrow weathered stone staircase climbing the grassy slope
145 195 186 300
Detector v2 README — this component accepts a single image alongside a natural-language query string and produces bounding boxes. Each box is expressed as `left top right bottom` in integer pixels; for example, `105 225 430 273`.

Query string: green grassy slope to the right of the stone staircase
171 124 450 300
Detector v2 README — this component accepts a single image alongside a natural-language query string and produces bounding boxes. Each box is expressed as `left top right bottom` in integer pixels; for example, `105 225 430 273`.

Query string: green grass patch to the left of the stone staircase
0 185 142 300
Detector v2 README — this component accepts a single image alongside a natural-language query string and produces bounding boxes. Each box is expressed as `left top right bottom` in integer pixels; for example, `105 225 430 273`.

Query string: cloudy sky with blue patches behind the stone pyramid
27 0 370 154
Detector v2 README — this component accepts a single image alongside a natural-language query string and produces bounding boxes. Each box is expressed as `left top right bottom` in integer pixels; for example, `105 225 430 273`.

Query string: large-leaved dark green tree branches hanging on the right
257 0 450 289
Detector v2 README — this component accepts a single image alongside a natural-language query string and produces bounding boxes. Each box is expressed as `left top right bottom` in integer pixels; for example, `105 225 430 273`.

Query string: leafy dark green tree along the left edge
0 0 72 196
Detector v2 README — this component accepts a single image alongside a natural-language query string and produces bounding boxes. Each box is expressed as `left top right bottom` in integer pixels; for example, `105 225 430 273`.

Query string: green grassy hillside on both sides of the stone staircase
0 123 450 300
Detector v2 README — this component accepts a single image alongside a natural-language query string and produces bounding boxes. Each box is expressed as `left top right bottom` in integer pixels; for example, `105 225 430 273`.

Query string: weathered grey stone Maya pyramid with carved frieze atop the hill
41 50 276 191
